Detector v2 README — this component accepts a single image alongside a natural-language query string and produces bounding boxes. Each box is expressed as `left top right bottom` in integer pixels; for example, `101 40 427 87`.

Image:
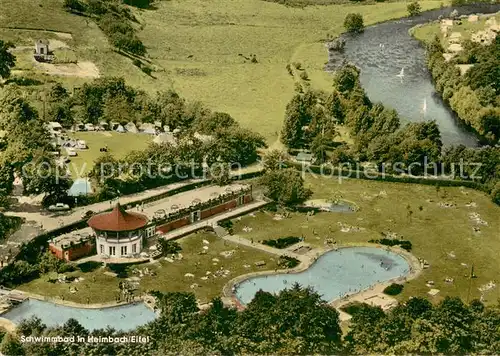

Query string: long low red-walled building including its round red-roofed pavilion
50 184 253 261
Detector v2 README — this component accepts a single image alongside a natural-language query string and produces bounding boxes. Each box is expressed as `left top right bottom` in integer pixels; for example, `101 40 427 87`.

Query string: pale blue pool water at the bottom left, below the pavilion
1 299 156 331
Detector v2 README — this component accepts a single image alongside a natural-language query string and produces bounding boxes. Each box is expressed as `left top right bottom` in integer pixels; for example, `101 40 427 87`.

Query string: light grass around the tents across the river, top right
412 13 500 44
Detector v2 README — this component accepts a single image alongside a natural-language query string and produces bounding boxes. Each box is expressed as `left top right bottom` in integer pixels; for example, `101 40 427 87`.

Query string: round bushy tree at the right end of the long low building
260 168 311 206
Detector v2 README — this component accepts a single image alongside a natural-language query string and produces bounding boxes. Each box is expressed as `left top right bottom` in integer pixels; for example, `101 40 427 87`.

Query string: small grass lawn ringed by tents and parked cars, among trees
63 131 152 178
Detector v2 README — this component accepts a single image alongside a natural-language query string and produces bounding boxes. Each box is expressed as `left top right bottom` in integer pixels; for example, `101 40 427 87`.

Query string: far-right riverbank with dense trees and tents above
409 12 500 145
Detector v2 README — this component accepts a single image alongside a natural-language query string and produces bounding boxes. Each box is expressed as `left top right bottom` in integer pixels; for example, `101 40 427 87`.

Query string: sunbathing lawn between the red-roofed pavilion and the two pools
18 233 277 303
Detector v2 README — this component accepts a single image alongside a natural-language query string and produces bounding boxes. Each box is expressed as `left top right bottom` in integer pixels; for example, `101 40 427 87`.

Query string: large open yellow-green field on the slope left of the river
0 0 447 144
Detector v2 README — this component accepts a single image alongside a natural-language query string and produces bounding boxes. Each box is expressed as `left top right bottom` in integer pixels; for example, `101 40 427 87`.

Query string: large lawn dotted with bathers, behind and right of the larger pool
229 176 500 303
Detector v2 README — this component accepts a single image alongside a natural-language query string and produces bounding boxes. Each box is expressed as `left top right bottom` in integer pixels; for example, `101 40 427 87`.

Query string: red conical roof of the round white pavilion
88 203 148 231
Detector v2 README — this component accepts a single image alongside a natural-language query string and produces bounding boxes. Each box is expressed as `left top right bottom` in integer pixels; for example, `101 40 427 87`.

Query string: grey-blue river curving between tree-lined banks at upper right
327 4 500 147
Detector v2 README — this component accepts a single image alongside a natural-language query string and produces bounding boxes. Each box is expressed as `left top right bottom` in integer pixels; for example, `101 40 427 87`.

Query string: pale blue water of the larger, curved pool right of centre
235 247 410 304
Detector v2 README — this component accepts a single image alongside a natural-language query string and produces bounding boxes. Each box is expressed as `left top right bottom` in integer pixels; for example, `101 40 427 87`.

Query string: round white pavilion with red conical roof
88 203 149 258
